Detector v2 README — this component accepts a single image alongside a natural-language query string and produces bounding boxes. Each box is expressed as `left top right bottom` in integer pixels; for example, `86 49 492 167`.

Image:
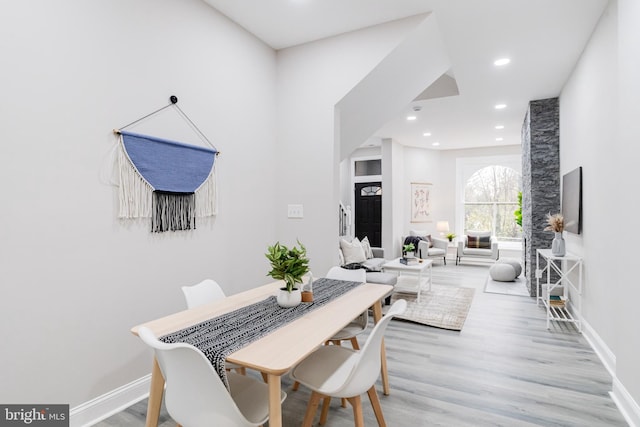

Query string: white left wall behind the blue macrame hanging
0 0 277 407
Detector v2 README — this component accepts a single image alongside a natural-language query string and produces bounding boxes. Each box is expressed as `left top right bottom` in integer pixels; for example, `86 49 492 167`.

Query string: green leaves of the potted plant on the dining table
265 240 309 292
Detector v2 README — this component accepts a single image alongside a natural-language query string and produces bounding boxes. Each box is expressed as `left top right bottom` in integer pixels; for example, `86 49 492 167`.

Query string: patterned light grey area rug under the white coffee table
391 284 475 331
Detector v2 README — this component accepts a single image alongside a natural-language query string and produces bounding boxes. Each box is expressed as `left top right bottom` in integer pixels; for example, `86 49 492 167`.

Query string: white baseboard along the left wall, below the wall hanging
69 374 151 427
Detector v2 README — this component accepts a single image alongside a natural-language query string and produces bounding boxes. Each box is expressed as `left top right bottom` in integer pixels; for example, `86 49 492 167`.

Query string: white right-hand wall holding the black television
560 0 640 425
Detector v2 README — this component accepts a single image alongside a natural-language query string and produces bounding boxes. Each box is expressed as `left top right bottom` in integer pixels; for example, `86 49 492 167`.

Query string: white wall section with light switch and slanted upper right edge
275 17 424 276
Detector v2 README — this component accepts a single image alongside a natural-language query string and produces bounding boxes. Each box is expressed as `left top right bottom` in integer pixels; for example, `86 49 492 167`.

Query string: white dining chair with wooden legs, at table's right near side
290 300 407 427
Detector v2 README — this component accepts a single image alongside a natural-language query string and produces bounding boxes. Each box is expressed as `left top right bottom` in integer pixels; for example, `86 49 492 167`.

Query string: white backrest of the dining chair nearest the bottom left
138 327 255 427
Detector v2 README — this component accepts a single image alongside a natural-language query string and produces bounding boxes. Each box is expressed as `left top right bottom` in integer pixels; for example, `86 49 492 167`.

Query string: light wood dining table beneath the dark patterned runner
131 281 393 427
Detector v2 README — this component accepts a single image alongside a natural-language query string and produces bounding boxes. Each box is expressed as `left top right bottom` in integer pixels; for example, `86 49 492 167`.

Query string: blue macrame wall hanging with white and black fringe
114 96 219 232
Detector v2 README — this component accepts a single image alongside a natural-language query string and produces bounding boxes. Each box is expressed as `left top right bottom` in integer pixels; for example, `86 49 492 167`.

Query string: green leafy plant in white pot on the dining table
265 241 309 307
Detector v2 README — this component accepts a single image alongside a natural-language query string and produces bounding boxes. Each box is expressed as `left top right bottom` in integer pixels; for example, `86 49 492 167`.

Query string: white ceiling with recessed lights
205 0 608 149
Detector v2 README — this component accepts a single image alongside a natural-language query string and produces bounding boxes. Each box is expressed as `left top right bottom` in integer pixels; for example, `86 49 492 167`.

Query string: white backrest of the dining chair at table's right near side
339 299 407 396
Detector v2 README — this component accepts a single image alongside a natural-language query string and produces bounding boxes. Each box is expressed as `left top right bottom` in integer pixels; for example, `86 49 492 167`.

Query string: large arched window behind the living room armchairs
464 165 522 242
